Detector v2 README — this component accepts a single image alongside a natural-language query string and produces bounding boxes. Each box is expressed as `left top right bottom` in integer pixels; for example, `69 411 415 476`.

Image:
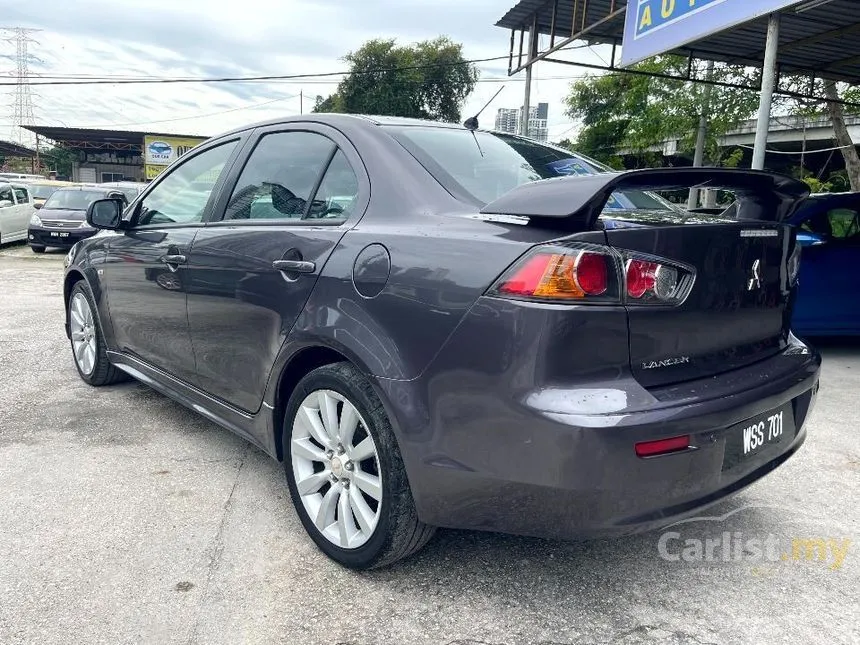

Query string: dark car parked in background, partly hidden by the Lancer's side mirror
27 186 127 253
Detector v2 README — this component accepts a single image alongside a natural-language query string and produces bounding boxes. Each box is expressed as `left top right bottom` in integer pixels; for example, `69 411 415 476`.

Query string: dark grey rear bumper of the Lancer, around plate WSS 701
380 302 821 538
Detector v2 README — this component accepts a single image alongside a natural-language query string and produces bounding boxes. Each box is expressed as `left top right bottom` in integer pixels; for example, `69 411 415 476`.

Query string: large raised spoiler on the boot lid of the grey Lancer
481 168 809 230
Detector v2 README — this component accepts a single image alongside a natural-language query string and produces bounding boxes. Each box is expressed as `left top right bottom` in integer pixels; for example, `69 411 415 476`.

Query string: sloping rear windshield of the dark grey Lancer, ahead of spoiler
390 127 673 210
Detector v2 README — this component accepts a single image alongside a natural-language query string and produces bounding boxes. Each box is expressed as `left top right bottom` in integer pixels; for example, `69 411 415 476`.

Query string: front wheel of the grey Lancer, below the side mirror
69 280 125 385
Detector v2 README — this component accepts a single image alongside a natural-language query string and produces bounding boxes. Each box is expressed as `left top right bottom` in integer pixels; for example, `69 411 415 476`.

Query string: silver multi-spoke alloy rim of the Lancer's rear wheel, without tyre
290 390 382 549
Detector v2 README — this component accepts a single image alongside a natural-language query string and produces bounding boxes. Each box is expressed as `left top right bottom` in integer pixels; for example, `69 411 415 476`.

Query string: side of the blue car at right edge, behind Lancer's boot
792 207 860 335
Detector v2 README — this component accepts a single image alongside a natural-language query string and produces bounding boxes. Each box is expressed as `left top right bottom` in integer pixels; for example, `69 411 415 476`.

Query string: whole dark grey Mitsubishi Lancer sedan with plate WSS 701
64 114 820 568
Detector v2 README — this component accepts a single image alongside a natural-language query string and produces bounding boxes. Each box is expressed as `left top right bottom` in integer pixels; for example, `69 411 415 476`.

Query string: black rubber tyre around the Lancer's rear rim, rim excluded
282 363 436 569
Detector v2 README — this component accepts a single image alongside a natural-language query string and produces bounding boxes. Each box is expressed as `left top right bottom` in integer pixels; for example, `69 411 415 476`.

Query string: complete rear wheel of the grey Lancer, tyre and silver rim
283 363 435 569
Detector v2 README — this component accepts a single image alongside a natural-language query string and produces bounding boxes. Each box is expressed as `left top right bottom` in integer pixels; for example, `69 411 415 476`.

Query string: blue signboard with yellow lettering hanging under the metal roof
621 0 803 67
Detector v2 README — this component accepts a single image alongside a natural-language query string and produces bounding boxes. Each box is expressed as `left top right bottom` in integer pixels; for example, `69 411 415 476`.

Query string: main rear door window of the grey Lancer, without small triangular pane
224 132 337 220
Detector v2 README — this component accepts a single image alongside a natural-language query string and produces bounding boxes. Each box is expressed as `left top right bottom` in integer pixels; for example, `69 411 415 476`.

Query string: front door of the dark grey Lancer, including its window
103 137 239 383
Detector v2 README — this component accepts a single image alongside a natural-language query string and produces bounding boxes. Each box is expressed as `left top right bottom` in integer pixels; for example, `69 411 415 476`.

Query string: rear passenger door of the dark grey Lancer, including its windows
188 124 369 412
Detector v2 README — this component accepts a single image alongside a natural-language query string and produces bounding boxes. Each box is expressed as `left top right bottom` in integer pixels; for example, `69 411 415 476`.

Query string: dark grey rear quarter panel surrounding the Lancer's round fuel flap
287 215 602 380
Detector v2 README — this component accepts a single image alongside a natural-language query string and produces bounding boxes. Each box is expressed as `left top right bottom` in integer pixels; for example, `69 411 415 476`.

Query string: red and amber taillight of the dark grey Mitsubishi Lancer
488 244 695 305
